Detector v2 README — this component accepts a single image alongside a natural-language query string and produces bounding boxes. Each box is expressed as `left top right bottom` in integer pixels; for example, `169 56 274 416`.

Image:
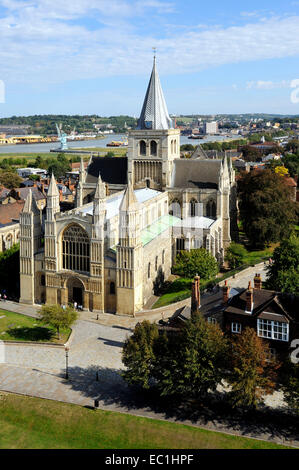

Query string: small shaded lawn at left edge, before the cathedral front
0 309 71 344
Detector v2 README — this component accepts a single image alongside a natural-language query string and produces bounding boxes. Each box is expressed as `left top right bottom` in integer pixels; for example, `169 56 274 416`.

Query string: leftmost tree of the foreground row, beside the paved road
122 320 159 389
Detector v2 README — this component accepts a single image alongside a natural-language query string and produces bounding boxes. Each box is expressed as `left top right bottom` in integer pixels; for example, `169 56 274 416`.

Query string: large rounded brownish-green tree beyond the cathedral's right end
239 170 295 248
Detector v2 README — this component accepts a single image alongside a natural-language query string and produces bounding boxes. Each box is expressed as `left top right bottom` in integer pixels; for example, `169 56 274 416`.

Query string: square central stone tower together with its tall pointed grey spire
127 57 180 191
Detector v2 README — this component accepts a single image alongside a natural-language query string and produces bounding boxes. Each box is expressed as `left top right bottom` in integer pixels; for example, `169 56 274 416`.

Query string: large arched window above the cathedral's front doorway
62 224 90 272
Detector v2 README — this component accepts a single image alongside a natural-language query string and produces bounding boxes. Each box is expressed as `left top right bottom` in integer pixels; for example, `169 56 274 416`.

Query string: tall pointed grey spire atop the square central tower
137 55 173 130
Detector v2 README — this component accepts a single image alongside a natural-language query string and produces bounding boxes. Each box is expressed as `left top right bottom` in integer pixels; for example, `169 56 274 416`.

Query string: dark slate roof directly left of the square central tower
85 157 128 184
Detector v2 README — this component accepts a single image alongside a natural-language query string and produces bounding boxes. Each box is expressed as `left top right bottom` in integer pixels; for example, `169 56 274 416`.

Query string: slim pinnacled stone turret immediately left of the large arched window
45 173 60 304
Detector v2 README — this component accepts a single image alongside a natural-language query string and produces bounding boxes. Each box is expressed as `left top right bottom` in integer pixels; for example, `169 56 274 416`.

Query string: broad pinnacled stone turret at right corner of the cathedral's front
116 181 143 315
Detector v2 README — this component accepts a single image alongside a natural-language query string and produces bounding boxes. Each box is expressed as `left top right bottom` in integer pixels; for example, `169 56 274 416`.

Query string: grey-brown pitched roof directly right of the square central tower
170 159 222 189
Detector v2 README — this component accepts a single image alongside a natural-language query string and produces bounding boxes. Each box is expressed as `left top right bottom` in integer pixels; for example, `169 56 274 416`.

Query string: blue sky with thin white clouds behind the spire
0 0 299 117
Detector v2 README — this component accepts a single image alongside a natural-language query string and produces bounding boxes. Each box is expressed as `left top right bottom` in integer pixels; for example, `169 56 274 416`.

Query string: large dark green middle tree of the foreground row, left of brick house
153 313 227 399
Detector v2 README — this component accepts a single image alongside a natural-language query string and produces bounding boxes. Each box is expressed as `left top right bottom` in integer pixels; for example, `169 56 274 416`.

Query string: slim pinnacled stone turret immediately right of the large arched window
90 175 106 311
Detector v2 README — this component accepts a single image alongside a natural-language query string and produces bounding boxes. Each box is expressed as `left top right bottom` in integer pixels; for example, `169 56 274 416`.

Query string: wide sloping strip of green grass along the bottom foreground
0 393 287 449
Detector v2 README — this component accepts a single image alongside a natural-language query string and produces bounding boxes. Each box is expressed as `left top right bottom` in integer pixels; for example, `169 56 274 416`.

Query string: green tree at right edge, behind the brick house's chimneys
266 235 299 294
